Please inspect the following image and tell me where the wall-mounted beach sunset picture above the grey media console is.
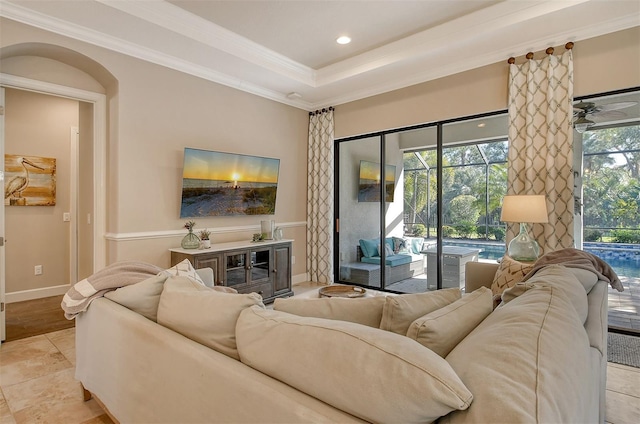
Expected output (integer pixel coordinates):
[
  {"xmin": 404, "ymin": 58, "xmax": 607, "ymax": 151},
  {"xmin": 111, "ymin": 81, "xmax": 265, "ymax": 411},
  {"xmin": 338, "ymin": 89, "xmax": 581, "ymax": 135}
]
[{"xmin": 180, "ymin": 148, "xmax": 280, "ymax": 218}]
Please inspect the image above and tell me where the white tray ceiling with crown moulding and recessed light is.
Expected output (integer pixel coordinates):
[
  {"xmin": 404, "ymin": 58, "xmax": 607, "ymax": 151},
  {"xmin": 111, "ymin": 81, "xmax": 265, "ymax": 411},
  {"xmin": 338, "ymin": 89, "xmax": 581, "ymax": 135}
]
[{"xmin": 0, "ymin": 0, "xmax": 640, "ymax": 110}]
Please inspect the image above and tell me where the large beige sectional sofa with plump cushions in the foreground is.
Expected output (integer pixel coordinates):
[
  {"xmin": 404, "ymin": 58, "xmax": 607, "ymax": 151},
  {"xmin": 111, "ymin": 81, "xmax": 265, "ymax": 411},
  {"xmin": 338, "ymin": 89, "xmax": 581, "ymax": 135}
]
[{"xmin": 76, "ymin": 263, "xmax": 607, "ymax": 423}]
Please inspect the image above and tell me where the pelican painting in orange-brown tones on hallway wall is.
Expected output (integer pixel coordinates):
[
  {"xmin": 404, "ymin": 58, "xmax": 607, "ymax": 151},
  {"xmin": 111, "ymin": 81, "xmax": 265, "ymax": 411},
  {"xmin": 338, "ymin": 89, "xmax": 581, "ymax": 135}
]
[{"xmin": 4, "ymin": 155, "xmax": 56, "ymax": 206}]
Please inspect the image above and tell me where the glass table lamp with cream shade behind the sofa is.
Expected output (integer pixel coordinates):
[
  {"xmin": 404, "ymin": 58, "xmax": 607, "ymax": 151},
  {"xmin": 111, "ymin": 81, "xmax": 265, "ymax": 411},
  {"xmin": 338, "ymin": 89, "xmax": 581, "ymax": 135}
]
[{"xmin": 500, "ymin": 194, "xmax": 549, "ymax": 262}]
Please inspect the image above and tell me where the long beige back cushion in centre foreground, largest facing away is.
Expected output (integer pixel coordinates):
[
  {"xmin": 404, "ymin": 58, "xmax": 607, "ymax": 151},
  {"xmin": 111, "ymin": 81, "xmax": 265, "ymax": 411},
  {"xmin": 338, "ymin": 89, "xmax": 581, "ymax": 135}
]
[{"xmin": 236, "ymin": 307, "xmax": 472, "ymax": 423}]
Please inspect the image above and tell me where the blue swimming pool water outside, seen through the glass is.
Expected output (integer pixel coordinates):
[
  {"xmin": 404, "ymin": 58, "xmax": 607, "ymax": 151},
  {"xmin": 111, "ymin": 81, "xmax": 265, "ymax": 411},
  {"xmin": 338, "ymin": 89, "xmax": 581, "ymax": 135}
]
[{"xmin": 444, "ymin": 239, "xmax": 640, "ymax": 278}]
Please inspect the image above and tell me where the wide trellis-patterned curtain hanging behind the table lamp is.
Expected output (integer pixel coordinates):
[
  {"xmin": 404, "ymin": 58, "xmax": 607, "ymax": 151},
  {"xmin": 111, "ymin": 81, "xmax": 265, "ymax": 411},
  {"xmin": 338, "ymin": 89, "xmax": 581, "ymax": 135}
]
[{"xmin": 507, "ymin": 48, "xmax": 574, "ymax": 255}]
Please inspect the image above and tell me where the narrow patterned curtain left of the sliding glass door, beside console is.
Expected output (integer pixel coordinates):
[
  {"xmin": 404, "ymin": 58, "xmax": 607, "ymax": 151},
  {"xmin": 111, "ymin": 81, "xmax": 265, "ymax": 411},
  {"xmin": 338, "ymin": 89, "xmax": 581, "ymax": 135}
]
[{"xmin": 307, "ymin": 108, "xmax": 334, "ymax": 283}]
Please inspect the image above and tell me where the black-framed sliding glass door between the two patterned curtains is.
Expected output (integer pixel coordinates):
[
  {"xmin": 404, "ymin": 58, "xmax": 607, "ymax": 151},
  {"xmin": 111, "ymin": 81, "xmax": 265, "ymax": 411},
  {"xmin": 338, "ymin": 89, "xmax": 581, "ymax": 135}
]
[{"xmin": 336, "ymin": 113, "xmax": 507, "ymax": 293}]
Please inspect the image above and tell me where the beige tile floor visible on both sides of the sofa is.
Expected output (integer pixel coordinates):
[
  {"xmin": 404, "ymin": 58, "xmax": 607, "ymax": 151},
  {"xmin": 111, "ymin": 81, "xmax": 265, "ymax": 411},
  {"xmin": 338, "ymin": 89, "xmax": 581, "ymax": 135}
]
[{"xmin": 0, "ymin": 328, "xmax": 640, "ymax": 424}]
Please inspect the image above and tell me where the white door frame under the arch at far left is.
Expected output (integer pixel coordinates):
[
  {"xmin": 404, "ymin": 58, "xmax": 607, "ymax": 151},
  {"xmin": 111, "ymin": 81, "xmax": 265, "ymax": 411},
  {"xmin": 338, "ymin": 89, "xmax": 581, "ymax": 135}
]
[{"xmin": 0, "ymin": 73, "xmax": 107, "ymax": 340}]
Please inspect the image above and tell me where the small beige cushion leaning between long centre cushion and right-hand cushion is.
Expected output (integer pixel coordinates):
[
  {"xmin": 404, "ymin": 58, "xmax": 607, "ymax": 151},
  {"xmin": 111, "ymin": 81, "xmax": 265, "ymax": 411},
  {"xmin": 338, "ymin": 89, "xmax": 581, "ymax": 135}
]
[{"xmin": 407, "ymin": 287, "xmax": 493, "ymax": 358}]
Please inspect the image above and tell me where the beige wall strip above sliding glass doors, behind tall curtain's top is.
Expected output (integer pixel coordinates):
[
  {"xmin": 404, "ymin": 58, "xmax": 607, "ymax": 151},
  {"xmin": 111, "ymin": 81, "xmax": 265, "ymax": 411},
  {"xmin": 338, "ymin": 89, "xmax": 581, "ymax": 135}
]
[{"xmin": 334, "ymin": 27, "xmax": 640, "ymax": 138}]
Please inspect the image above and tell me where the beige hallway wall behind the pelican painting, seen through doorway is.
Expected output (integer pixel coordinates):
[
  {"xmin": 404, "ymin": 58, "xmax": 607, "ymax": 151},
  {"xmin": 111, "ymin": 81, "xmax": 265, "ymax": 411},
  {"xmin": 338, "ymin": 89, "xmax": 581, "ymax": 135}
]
[{"xmin": 5, "ymin": 89, "xmax": 78, "ymax": 293}]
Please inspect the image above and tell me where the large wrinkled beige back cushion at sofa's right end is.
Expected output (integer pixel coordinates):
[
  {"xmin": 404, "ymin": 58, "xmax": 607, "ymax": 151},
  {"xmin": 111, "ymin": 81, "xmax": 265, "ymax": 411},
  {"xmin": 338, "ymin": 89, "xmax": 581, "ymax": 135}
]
[{"xmin": 439, "ymin": 287, "xmax": 600, "ymax": 423}]
